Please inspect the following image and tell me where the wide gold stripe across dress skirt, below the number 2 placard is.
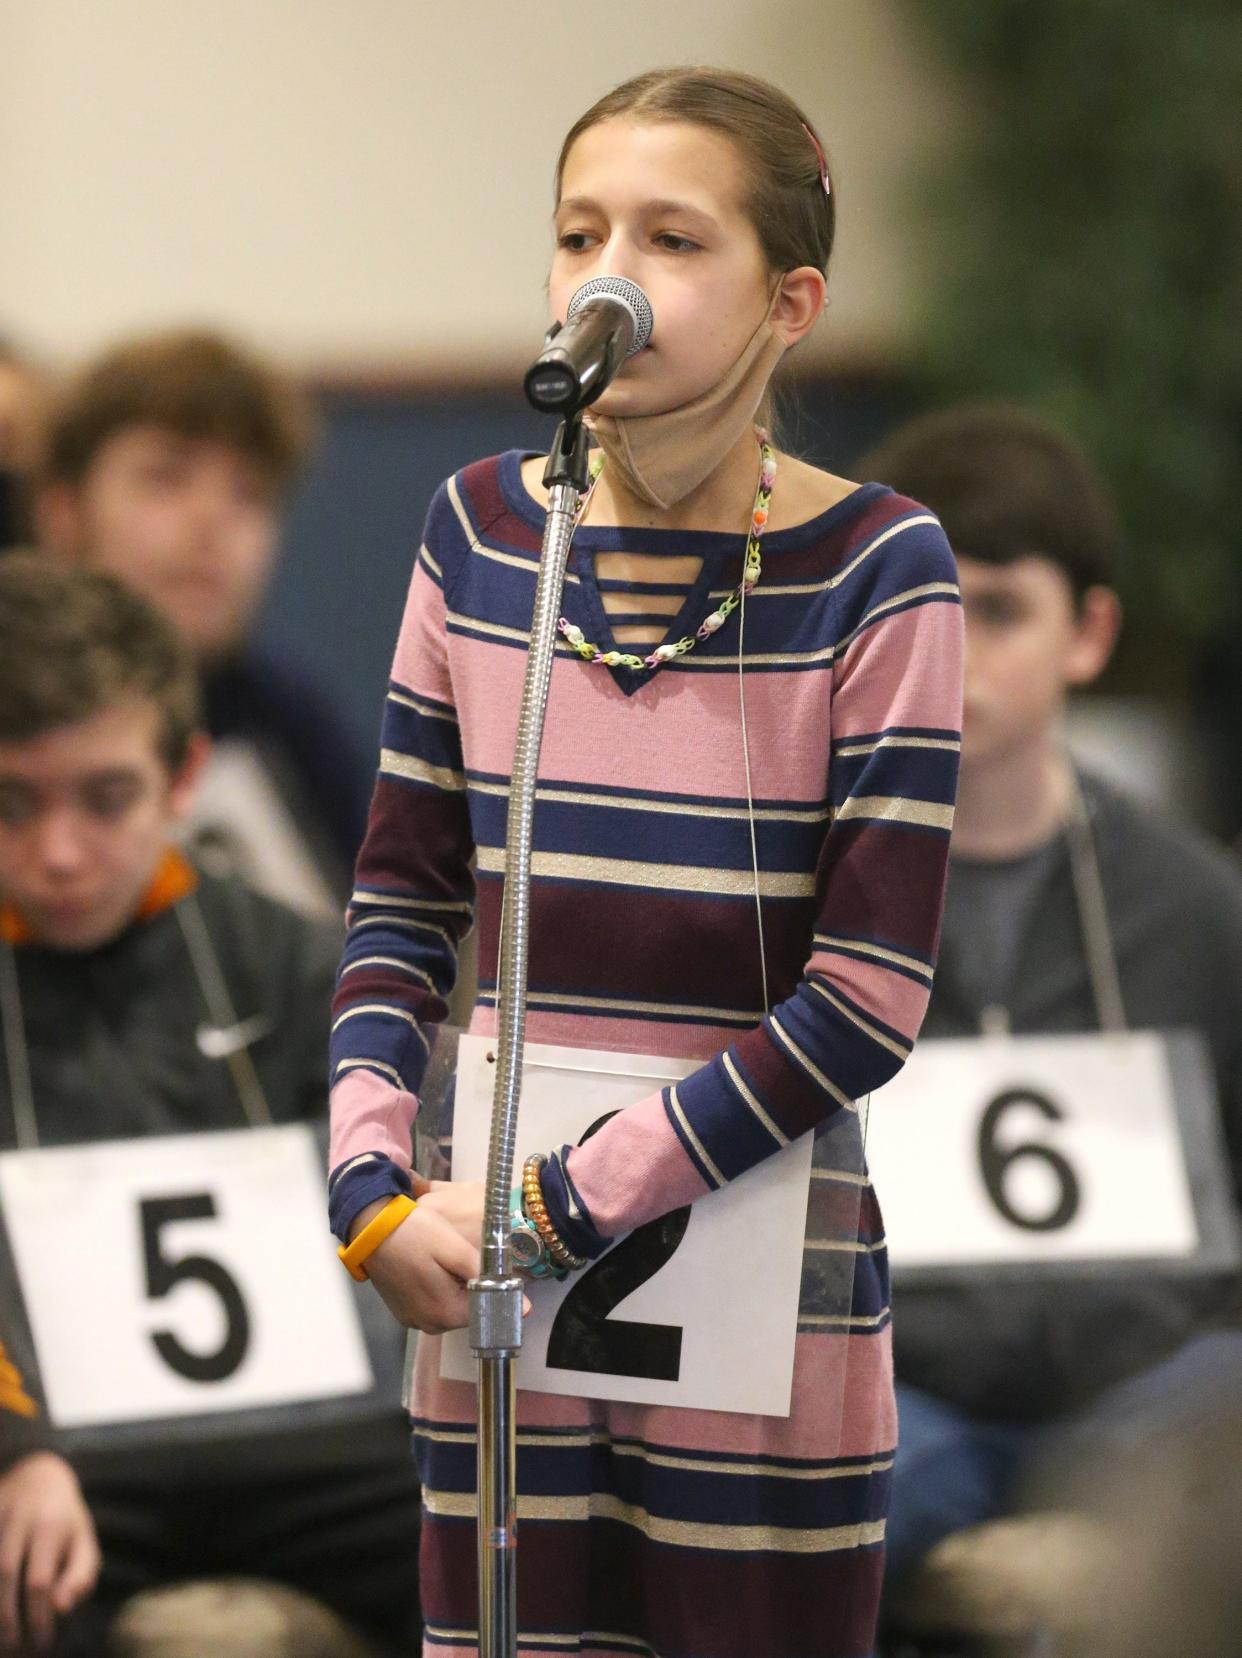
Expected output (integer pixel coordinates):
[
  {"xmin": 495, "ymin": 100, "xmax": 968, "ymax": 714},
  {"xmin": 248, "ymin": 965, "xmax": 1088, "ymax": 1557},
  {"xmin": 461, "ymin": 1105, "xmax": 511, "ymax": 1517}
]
[{"xmin": 423, "ymin": 1489, "xmax": 884, "ymax": 1555}]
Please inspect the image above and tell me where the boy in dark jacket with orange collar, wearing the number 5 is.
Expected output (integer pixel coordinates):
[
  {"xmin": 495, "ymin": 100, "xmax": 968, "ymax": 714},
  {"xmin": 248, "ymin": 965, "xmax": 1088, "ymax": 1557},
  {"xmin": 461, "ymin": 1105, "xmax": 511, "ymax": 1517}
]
[{"xmin": 0, "ymin": 554, "xmax": 418, "ymax": 1651}]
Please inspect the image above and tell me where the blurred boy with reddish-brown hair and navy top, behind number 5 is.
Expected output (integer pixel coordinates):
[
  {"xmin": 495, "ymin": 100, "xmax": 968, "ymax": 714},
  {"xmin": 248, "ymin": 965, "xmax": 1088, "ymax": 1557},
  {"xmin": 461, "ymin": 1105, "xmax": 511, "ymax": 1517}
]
[{"xmin": 35, "ymin": 330, "xmax": 370, "ymax": 915}]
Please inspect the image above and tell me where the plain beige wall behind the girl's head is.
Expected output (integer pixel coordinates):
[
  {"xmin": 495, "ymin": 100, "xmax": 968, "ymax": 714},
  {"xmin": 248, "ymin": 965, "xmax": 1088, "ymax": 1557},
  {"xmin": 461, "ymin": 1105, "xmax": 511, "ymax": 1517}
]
[{"xmin": 0, "ymin": 0, "xmax": 952, "ymax": 373}]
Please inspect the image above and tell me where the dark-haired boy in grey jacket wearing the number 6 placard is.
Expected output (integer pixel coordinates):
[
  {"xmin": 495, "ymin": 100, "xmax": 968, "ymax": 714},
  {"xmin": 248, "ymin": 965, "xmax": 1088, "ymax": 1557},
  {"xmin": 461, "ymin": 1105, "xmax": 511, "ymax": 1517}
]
[{"xmin": 866, "ymin": 405, "xmax": 1242, "ymax": 1580}]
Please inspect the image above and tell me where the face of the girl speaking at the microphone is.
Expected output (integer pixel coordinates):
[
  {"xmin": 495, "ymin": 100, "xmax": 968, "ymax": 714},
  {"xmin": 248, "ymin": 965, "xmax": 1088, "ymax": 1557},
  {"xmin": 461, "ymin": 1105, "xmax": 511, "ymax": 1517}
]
[{"xmin": 549, "ymin": 116, "xmax": 778, "ymax": 416}]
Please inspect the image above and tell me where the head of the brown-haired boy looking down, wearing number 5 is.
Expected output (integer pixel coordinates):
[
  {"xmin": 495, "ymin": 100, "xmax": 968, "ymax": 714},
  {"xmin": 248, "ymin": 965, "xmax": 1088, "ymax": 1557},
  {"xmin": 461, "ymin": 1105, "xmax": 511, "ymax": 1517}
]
[{"xmin": 0, "ymin": 554, "xmax": 207, "ymax": 950}]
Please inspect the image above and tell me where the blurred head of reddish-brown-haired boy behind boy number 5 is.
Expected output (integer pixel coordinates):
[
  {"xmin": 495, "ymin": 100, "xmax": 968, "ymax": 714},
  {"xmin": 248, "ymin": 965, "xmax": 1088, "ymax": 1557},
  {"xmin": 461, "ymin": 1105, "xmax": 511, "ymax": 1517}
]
[{"xmin": 35, "ymin": 330, "xmax": 307, "ymax": 663}]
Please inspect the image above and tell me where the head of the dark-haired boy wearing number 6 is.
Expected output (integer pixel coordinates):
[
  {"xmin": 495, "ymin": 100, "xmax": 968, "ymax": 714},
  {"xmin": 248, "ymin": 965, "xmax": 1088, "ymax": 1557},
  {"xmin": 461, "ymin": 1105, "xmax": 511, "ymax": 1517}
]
[{"xmin": 866, "ymin": 403, "xmax": 1121, "ymax": 781}]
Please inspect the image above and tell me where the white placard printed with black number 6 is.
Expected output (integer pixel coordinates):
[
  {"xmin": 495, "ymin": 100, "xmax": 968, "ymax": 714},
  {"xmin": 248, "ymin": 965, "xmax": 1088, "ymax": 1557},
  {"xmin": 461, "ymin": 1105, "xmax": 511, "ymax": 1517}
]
[{"xmin": 867, "ymin": 1031, "xmax": 1199, "ymax": 1267}]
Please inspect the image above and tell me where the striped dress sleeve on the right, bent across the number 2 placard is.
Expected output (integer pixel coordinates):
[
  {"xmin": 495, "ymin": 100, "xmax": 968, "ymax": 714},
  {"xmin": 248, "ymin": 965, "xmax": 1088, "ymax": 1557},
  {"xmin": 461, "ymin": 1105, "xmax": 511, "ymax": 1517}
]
[{"xmin": 544, "ymin": 514, "xmax": 962, "ymax": 1255}]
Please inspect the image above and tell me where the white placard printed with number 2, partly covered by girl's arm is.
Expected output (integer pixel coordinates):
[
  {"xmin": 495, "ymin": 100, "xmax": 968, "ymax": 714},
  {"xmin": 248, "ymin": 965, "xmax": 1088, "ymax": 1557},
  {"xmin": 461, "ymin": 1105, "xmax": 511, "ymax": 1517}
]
[{"xmin": 441, "ymin": 1036, "xmax": 813, "ymax": 1416}]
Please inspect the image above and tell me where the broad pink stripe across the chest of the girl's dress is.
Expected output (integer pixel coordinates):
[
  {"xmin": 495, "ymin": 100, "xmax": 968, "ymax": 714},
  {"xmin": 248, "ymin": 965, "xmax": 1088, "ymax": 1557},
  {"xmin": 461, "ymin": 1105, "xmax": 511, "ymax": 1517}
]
[{"xmin": 449, "ymin": 635, "xmax": 829, "ymax": 802}]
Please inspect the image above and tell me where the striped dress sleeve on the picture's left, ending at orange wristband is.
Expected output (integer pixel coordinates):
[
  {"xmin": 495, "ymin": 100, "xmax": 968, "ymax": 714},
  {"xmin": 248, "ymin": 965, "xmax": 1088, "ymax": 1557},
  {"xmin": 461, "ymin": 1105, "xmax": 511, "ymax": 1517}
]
[{"xmin": 330, "ymin": 489, "xmax": 474, "ymax": 1237}]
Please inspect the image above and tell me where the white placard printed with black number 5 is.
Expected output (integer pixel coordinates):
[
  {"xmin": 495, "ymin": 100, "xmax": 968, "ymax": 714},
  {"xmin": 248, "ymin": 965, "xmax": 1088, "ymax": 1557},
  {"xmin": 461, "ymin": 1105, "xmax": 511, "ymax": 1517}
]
[{"xmin": 0, "ymin": 1124, "xmax": 373, "ymax": 1428}]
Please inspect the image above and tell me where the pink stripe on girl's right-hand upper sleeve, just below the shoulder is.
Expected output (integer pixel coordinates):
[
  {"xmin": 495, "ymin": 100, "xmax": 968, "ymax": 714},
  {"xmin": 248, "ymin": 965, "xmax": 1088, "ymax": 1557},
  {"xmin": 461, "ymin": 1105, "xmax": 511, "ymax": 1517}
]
[{"xmin": 834, "ymin": 604, "xmax": 962, "ymax": 741}]
